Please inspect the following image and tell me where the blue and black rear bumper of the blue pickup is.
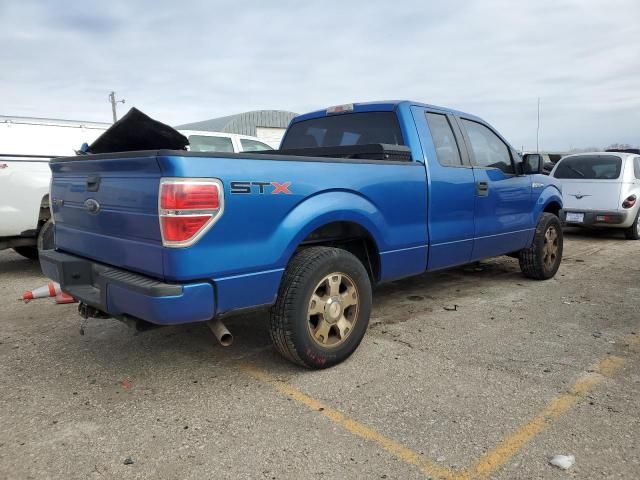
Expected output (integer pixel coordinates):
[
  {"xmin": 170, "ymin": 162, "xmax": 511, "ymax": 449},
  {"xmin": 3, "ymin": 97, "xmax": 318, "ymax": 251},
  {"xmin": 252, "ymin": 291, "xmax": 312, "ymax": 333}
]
[{"xmin": 40, "ymin": 250, "xmax": 215, "ymax": 325}]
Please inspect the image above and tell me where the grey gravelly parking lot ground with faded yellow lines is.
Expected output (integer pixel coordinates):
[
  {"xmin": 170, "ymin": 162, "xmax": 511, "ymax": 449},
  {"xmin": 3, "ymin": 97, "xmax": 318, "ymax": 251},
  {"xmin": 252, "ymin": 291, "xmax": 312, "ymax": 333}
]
[{"xmin": 0, "ymin": 231, "xmax": 640, "ymax": 479}]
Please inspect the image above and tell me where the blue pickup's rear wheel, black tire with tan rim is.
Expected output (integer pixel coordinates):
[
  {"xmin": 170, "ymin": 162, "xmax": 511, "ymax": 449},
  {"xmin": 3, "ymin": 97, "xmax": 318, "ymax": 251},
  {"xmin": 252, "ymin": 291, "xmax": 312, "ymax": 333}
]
[{"xmin": 269, "ymin": 247, "xmax": 371, "ymax": 369}]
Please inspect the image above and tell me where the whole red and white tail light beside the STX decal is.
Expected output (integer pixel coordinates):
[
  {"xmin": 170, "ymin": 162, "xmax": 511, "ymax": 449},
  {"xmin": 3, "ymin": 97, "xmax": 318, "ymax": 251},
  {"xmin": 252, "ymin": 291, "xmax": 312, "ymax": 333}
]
[{"xmin": 158, "ymin": 178, "xmax": 224, "ymax": 248}]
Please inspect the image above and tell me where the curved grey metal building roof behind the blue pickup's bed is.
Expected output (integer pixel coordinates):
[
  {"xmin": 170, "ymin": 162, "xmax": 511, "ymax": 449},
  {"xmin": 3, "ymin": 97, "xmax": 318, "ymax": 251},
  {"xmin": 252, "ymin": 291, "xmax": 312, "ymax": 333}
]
[{"xmin": 175, "ymin": 110, "xmax": 297, "ymax": 137}]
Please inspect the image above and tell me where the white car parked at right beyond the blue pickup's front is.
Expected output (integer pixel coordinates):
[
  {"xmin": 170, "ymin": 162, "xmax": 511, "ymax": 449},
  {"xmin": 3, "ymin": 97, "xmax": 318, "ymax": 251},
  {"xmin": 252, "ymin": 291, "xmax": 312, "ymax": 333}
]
[{"xmin": 551, "ymin": 152, "xmax": 640, "ymax": 240}]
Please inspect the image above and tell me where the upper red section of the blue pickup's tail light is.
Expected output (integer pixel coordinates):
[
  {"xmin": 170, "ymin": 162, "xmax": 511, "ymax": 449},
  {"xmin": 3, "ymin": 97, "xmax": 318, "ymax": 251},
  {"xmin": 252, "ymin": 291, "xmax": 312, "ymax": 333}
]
[{"xmin": 160, "ymin": 182, "xmax": 220, "ymax": 210}]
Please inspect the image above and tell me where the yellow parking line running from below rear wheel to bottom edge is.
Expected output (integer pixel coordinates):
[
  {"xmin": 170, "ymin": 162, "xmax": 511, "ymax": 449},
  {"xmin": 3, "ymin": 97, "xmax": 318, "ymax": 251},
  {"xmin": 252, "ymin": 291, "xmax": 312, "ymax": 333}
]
[{"xmin": 240, "ymin": 364, "xmax": 459, "ymax": 480}]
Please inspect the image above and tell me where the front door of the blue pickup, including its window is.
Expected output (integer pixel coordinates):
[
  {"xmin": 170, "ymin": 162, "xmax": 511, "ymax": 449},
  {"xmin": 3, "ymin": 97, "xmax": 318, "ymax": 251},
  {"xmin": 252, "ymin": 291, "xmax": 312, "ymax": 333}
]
[{"xmin": 459, "ymin": 117, "xmax": 535, "ymax": 260}]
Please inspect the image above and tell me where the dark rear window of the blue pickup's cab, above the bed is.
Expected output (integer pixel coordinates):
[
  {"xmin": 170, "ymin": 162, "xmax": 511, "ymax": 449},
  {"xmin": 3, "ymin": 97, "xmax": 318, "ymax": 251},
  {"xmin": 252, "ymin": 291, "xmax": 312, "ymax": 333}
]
[{"xmin": 280, "ymin": 112, "xmax": 405, "ymax": 150}]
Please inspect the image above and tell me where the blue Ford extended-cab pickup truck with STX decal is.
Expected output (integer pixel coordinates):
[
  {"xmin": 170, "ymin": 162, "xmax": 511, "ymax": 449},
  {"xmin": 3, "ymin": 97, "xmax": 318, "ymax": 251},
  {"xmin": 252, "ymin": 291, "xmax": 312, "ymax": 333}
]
[{"xmin": 40, "ymin": 101, "xmax": 562, "ymax": 368}]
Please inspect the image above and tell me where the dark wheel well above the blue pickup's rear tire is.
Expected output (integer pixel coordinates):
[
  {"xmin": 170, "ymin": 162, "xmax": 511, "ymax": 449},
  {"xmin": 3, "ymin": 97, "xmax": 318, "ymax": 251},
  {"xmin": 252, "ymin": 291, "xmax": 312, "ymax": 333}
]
[{"xmin": 298, "ymin": 222, "xmax": 380, "ymax": 282}]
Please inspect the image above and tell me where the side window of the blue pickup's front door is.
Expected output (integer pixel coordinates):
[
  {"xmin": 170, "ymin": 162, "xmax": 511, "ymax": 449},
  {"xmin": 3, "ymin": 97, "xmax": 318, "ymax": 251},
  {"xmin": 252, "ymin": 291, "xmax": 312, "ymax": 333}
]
[{"xmin": 462, "ymin": 118, "xmax": 515, "ymax": 173}]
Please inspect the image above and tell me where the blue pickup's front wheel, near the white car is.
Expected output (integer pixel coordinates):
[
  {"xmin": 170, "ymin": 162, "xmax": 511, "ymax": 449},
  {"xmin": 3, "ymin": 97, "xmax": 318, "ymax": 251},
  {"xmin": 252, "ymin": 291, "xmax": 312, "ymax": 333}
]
[{"xmin": 520, "ymin": 213, "xmax": 563, "ymax": 280}]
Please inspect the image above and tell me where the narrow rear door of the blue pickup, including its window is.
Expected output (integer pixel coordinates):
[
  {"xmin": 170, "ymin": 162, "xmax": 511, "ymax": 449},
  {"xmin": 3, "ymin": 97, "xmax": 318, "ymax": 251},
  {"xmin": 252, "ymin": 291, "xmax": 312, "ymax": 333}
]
[{"xmin": 412, "ymin": 107, "xmax": 475, "ymax": 270}]
